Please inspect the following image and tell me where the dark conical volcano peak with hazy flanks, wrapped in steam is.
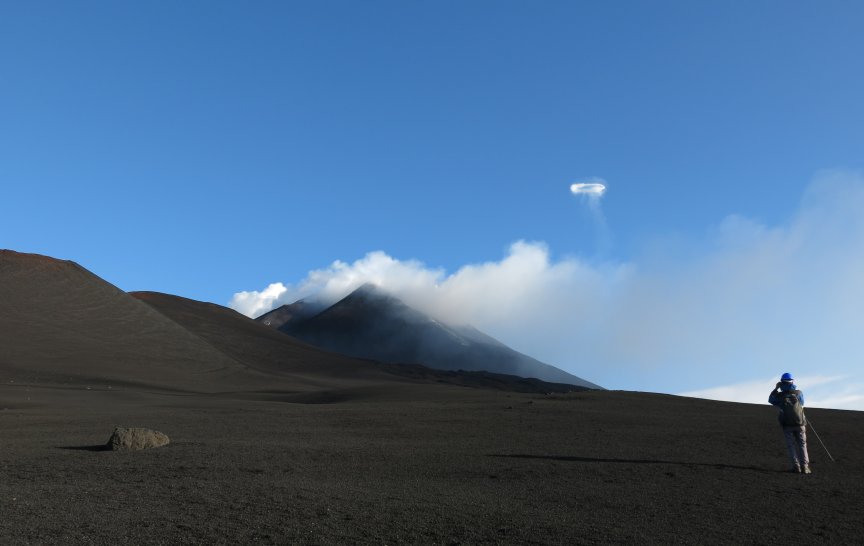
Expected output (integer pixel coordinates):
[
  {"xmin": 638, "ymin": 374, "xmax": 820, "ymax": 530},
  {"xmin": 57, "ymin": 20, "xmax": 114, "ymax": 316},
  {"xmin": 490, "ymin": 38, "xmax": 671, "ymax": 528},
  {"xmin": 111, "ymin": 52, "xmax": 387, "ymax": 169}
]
[{"xmin": 256, "ymin": 284, "xmax": 602, "ymax": 389}]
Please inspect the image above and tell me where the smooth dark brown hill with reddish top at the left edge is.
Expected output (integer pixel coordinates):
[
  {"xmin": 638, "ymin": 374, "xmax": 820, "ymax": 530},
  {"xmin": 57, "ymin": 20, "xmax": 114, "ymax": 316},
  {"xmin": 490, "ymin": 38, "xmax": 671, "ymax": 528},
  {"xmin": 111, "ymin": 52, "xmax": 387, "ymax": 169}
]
[{"xmin": 0, "ymin": 250, "xmax": 263, "ymax": 392}]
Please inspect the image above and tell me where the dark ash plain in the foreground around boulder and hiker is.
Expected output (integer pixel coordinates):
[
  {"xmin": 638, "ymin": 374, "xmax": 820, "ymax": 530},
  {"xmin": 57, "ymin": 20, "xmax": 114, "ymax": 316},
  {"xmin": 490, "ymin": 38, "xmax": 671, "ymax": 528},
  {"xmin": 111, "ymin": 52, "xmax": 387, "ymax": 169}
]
[{"xmin": 0, "ymin": 384, "xmax": 864, "ymax": 545}]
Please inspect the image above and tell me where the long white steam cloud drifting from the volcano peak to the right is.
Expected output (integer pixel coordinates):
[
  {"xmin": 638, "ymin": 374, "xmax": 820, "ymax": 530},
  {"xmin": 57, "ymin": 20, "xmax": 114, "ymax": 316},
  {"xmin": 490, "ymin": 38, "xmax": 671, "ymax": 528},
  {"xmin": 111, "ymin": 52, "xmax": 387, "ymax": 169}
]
[{"xmin": 230, "ymin": 172, "xmax": 864, "ymax": 409}]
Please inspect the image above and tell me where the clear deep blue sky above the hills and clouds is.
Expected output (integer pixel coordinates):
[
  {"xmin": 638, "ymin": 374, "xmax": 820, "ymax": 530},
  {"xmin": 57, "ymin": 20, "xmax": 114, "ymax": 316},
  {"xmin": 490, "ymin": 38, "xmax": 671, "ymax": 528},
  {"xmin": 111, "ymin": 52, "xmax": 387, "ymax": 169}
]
[{"xmin": 0, "ymin": 1, "xmax": 864, "ymax": 404}]
